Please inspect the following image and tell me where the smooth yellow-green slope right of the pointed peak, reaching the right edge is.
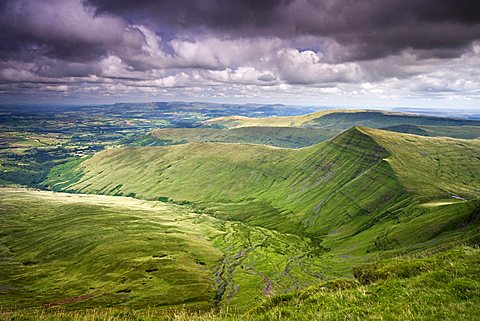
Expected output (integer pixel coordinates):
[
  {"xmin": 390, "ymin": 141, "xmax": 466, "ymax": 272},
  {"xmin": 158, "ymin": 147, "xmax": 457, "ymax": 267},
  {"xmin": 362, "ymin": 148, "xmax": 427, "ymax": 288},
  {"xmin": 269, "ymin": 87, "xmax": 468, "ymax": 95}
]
[{"xmin": 362, "ymin": 128, "xmax": 480, "ymax": 199}]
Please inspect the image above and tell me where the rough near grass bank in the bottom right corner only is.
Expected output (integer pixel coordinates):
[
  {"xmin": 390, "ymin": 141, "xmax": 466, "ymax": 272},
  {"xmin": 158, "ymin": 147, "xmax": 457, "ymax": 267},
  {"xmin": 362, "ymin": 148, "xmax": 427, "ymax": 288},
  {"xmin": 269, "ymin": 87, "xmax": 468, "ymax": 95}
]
[{"xmin": 252, "ymin": 247, "xmax": 480, "ymax": 320}]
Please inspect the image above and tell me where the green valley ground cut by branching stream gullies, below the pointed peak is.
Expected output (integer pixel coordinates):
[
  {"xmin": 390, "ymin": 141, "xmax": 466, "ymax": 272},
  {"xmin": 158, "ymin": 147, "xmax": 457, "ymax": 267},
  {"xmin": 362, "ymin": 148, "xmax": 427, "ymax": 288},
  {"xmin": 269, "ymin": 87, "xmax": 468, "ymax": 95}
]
[{"xmin": 213, "ymin": 221, "xmax": 323, "ymax": 306}]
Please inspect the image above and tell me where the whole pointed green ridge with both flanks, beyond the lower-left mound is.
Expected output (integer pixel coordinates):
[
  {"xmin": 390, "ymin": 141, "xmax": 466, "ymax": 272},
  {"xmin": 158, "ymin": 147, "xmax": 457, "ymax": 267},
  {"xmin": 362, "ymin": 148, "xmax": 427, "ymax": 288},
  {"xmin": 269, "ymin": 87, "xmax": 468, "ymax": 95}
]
[{"xmin": 45, "ymin": 128, "xmax": 480, "ymax": 254}]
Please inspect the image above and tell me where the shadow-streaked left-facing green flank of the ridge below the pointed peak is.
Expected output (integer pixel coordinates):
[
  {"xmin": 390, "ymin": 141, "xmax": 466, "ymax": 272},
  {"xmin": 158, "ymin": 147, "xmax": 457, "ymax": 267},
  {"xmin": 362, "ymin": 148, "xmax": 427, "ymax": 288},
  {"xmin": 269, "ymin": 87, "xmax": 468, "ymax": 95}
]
[{"xmin": 45, "ymin": 130, "xmax": 402, "ymax": 234}]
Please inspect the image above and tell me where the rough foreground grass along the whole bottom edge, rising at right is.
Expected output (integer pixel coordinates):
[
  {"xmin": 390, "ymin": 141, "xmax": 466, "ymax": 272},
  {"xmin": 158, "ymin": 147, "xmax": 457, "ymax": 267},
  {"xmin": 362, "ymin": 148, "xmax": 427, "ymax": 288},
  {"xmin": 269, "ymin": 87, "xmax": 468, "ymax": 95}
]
[{"xmin": 0, "ymin": 246, "xmax": 480, "ymax": 321}]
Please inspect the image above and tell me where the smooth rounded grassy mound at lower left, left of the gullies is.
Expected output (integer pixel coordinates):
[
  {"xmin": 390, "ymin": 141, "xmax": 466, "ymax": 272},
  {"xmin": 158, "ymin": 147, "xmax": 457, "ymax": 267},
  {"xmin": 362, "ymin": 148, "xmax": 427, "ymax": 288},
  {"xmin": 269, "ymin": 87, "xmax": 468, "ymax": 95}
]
[{"xmin": 0, "ymin": 189, "xmax": 222, "ymax": 307}]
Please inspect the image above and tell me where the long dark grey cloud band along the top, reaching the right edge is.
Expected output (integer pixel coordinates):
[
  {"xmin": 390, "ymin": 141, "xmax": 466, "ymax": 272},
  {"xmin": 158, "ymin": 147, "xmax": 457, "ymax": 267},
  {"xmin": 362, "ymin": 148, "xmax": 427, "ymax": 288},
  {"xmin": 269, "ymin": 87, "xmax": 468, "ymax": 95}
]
[{"xmin": 87, "ymin": 0, "xmax": 480, "ymax": 60}]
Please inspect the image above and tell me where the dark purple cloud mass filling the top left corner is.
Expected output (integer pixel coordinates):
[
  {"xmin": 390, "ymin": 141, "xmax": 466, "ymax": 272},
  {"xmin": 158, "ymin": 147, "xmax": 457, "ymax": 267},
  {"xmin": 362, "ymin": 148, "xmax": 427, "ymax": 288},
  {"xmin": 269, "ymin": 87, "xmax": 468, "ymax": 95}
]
[{"xmin": 0, "ymin": 0, "xmax": 144, "ymax": 61}]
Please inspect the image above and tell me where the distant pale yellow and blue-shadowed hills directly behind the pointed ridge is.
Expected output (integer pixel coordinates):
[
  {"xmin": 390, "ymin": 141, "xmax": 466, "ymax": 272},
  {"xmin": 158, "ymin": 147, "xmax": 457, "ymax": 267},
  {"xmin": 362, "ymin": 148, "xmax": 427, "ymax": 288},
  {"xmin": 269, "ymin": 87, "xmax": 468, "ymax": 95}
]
[{"xmin": 142, "ymin": 110, "xmax": 480, "ymax": 148}]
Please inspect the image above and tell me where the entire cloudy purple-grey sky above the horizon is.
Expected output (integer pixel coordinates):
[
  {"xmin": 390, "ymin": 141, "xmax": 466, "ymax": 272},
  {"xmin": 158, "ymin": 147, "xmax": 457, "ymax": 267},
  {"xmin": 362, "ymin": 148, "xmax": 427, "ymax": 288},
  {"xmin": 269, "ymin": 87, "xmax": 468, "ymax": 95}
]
[{"xmin": 0, "ymin": 0, "xmax": 480, "ymax": 109}]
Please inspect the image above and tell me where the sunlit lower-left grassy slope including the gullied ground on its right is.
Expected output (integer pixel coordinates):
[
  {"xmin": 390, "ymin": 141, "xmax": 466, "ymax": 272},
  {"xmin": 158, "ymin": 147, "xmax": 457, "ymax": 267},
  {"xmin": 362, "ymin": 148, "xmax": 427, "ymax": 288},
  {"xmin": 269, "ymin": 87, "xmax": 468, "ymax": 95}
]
[{"xmin": 0, "ymin": 188, "xmax": 332, "ymax": 309}]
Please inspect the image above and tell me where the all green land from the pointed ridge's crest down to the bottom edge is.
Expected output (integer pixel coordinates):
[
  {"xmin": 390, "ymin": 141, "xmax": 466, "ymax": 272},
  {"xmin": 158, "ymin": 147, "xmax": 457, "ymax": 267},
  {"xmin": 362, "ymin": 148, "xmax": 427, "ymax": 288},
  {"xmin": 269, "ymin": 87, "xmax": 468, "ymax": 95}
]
[{"xmin": 4, "ymin": 127, "xmax": 480, "ymax": 320}]
